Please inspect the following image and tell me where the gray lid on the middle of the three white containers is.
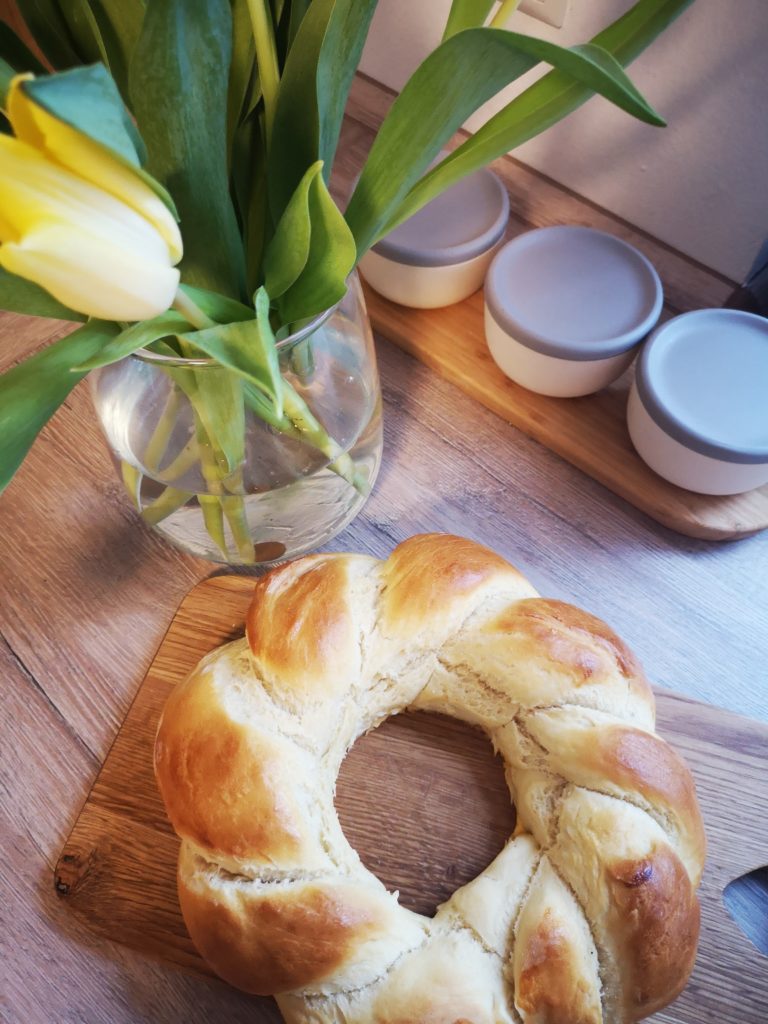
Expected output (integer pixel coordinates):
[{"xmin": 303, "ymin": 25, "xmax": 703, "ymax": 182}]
[{"xmin": 485, "ymin": 224, "xmax": 664, "ymax": 360}]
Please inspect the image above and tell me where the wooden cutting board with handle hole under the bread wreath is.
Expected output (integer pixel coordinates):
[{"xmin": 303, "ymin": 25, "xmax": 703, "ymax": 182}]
[{"xmin": 55, "ymin": 575, "xmax": 768, "ymax": 1024}]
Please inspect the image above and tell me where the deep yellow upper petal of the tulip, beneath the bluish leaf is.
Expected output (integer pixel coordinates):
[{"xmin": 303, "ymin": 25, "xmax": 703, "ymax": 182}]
[{"xmin": 8, "ymin": 75, "xmax": 183, "ymax": 263}]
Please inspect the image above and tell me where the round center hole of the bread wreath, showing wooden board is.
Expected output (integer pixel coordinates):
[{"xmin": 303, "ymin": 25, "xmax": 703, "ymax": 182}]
[{"xmin": 336, "ymin": 712, "xmax": 515, "ymax": 918}]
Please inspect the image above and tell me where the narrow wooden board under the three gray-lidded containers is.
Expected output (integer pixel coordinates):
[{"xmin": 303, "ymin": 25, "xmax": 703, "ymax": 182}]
[{"xmin": 366, "ymin": 286, "xmax": 768, "ymax": 541}]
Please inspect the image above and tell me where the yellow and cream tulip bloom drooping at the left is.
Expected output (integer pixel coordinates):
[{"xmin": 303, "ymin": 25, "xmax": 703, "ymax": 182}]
[{"xmin": 0, "ymin": 76, "xmax": 182, "ymax": 321}]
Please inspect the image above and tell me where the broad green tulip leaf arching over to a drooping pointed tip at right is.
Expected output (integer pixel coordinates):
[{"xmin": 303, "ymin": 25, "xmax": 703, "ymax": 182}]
[{"xmin": 346, "ymin": 29, "xmax": 664, "ymax": 256}]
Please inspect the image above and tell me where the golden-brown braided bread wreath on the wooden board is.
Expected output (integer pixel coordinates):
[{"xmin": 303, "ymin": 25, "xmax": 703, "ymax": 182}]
[{"xmin": 156, "ymin": 535, "xmax": 705, "ymax": 1024}]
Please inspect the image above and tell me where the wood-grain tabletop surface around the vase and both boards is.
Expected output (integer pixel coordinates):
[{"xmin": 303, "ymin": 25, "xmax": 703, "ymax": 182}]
[{"xmin": 0, "ymin": 64, "xmax": 768, "ymax": 1024}]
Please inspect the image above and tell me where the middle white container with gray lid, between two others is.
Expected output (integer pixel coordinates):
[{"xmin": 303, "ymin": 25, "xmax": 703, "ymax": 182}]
[{"xmin": 485, "ymin": 225, "xmax": 664, "ymax": 398}]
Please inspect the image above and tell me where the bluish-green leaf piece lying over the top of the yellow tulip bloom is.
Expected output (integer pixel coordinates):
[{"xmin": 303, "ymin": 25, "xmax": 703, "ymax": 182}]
[{"xmin": 22, "ymin": 65, "xmax": 178, "ymax": 220}]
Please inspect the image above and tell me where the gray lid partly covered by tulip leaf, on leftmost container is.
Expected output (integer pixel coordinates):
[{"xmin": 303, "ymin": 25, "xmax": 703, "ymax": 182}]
[{"xmin": 373, "ymin": 168, "xmax": 509, "ymax": 266}]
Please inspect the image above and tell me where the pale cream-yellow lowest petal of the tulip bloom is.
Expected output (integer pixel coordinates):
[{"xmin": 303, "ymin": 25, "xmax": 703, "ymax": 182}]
[{"xmin": 0, "ymin": 224, "xmax": 179, "ymax": 321}]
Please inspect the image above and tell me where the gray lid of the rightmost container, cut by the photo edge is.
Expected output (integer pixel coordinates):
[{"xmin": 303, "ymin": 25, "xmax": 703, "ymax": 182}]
[{"xmin": 637, "ymin": 309, "xmax": 768, "ymax": 463}]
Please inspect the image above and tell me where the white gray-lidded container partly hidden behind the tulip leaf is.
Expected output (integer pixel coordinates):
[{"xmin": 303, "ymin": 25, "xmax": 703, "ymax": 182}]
[{"xmin": 359, "ymin": 163, "xmax": 509, "ymax": 309}]
